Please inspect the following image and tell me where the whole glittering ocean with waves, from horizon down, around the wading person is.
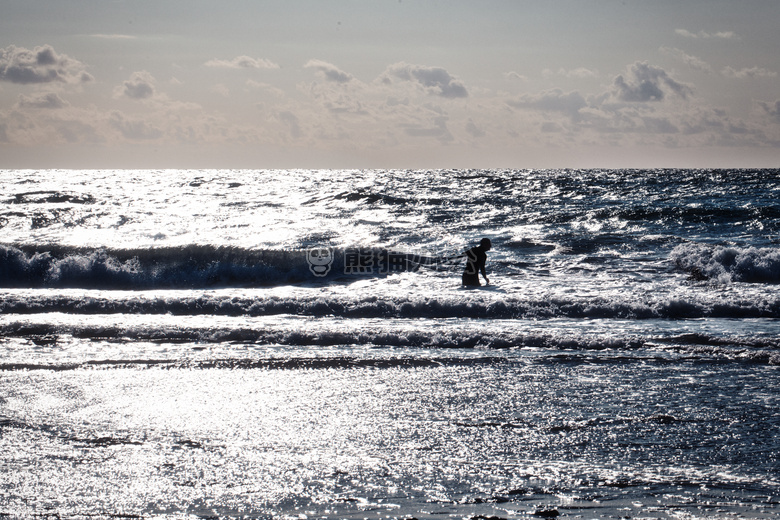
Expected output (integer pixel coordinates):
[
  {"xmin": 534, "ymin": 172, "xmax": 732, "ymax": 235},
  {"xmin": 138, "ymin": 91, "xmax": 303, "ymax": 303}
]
[{"xmin": 0, "ymin": 169, "xmax": 780, "ymax": 519}]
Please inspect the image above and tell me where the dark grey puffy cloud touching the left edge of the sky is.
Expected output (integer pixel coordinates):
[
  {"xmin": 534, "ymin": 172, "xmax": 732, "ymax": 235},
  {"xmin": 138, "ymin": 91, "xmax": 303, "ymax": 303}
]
[{"xmin": 0, "ymin": 45, "xmax": 94, "ymax": 85}]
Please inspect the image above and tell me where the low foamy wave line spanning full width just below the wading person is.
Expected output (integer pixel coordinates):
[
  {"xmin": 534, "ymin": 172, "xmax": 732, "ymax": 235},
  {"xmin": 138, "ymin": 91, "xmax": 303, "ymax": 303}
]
[{"xmin": 0, "ymin": 291, "xmax": 780, "ymax": 320}]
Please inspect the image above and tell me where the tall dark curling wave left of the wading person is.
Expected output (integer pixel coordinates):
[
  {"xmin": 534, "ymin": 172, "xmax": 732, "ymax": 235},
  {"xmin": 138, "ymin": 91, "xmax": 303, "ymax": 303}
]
[{"xmin": 0, "ymin": 245, "xmax": 454, "ymax": 289}]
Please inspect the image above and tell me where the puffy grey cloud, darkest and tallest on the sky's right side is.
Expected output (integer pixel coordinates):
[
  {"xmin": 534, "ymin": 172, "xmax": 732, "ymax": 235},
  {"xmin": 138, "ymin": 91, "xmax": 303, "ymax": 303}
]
[{"xmin": 613, "ymin": 62, "xmax": 693, "ymax": 103}]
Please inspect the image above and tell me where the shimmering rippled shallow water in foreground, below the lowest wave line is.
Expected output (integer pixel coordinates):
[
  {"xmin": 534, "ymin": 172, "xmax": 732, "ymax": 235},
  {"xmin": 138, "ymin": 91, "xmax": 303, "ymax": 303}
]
[{"xmin": 0, "ymin": 350, "xmax": 780, "ymax": 516}]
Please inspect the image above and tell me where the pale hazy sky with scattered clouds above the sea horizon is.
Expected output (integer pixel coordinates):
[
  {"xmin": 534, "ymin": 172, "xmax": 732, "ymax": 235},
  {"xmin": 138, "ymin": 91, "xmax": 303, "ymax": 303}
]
[{"xmin": 0, "ymin": 0, "xmax": 780, "ymax": 168}]
